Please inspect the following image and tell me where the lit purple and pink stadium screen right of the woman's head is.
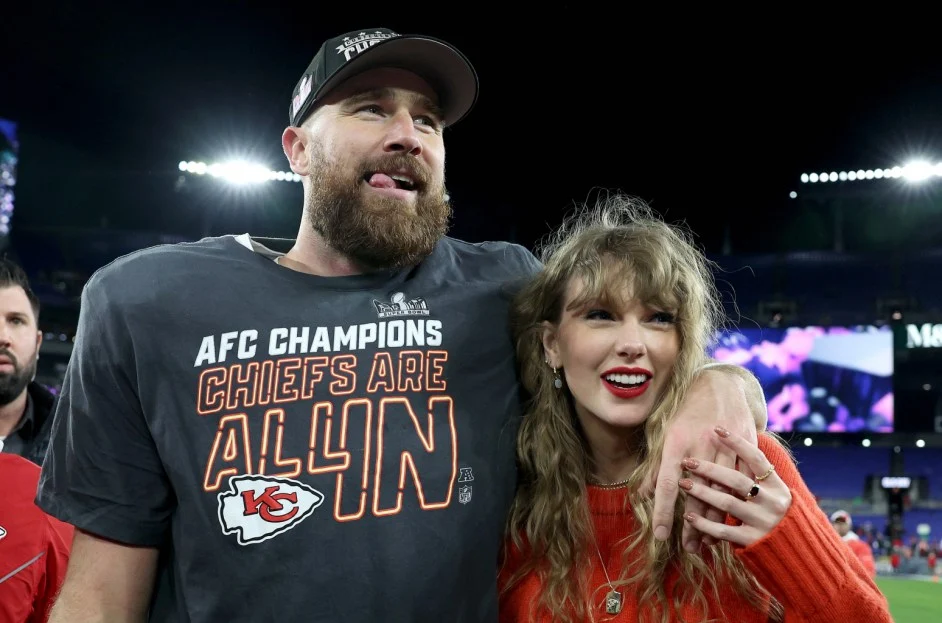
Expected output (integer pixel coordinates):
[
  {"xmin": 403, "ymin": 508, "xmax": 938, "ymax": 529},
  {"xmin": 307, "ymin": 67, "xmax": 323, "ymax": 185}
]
[{"xmin": 709, "ymin": 326, "xmax": 894, "ymax": 433}]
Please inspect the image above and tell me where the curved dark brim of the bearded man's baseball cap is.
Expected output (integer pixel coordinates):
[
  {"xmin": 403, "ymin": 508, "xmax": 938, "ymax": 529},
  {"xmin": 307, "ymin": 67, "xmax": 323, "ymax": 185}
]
[{"xmin": 310, "ymin": 35, "xmax": 478, "ymax": 125}]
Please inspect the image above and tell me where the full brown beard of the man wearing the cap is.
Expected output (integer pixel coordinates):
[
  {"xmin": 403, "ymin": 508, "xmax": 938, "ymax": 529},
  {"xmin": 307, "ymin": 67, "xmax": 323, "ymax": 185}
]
[{"xmin": 307, "ymin": 147, "xmax": 451, "ymax": 271}]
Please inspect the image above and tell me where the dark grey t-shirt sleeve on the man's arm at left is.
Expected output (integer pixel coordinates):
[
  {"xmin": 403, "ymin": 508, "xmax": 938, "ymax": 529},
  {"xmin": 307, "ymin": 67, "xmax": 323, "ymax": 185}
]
[{"xmin": 36, "ymin": 268, "xmax": 175, "ymax": 547}]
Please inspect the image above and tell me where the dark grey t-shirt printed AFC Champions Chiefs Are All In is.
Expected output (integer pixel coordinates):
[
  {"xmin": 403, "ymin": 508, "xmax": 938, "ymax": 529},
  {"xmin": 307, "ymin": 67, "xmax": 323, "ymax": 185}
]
[{"xmin": 37, "ymin": 236, "xmax": 539, "ymax": 623}]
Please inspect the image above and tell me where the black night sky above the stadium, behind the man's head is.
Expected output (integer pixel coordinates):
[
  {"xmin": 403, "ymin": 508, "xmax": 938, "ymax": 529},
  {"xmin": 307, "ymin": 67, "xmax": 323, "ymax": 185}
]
[{"xmin": 0, "ymin": 0, "xmax": 942, "ymax": 251}]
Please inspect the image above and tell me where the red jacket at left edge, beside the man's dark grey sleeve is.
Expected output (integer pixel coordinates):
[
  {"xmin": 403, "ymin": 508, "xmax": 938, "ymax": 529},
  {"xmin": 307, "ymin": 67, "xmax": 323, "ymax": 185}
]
[{"xmin": 0, "ymin": 453, "xmax": 73, "ymax": 623}]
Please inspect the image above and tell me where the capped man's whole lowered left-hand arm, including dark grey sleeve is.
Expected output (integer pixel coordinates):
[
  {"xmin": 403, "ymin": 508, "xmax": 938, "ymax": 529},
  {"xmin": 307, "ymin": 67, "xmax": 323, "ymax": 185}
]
[{"xmin": 36, "ymin": 272, "xmax": 170, "ymax": 623}]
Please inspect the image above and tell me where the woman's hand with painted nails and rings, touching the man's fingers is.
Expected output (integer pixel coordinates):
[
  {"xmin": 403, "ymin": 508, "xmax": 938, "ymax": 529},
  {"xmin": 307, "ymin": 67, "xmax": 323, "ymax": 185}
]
[{"xmin": 678, "ymin": 426, "xmax": 792, "ymax": 546}]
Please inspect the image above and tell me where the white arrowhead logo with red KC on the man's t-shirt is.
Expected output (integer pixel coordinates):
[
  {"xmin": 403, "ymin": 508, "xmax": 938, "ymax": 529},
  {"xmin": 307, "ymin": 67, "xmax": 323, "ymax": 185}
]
[{"xmin": 219, "ymin": 474, "xmax": 324, "ymax": 545}]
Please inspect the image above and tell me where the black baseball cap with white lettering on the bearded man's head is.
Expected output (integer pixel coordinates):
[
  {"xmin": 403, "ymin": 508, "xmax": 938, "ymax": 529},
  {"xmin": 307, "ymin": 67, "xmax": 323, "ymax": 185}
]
[{"xmin": 288, "ymin": 28, "xmax": 478, "ymax": 126}]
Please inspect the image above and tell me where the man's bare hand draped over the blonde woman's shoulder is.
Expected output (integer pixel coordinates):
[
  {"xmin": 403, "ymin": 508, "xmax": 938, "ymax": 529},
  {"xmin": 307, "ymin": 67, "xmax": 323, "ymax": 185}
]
[{"xmin": 643, "ymin": 365, "xmax": 767, "ymax": 551}]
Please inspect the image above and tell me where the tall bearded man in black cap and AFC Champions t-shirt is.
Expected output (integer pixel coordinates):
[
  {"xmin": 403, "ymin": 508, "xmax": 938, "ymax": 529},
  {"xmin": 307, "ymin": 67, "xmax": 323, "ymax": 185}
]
[{"xmin": 37, "ymin": 28, "xmax": 776, "ymax": 623}]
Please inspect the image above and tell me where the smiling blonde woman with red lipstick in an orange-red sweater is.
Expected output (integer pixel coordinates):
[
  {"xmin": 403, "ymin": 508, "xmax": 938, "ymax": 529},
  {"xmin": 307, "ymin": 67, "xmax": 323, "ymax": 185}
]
[{"xmin": 500, "ymin": 195, "xmax": 892, "ymax": 623}]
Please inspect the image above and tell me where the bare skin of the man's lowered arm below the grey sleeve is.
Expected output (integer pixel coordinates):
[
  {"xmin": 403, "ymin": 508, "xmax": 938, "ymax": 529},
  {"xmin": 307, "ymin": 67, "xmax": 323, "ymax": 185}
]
[{"xmin": 49, "ymin": 530, "xmax": 158, "ymax": 623}]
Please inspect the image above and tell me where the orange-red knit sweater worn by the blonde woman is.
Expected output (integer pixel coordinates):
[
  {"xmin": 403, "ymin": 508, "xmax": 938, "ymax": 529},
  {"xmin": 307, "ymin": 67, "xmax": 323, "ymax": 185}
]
[{"xmin": 500, "ymin": 435, "xmax": 893, "ymax": 623}]
